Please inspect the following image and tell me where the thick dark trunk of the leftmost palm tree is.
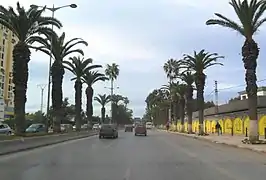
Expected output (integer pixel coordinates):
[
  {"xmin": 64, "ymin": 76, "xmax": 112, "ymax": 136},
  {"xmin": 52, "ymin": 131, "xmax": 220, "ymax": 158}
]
[{"xmin": 13, "ymin": 42, "xmax": 31, "ymax": 136}]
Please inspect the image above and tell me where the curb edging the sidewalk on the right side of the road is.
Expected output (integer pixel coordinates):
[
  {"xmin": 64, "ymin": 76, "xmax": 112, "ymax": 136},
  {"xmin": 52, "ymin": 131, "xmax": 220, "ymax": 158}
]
[{"xmin": 158, "ymin": 130, "xmax": 266, "ymax": 153}]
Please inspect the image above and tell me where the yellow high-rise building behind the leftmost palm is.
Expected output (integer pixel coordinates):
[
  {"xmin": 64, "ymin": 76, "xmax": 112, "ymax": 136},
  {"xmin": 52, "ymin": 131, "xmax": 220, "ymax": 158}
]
[{"xmin": 0, "ymin": 25, "xmax": 17, "ymax": 118}]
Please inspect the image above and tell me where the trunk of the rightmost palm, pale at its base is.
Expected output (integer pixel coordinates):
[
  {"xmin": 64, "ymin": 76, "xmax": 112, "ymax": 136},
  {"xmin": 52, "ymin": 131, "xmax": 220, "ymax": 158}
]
[{"xmin": 242, "ymin": 39, "xmax": 259, "ymax": 142}]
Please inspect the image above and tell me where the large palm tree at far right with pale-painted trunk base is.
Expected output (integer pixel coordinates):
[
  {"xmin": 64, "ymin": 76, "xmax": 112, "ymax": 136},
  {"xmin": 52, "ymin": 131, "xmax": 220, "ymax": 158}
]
[{"xmin": 206, "ymin": 0, "xmax": 266, "ymax": 142}]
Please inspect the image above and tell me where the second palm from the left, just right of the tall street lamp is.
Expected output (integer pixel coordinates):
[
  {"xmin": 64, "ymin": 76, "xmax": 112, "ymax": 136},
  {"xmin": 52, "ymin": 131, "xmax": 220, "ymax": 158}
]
[{"xmin": 38, "ymin": 33, "xmax": 88, "ymax": 132}]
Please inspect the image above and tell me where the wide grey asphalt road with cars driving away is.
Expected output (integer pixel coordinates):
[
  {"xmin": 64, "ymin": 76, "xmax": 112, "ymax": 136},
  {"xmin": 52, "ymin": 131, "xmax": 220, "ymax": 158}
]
[{"xmin": 0, "ymin": 131, "xmax": 266, "ymax": 180}]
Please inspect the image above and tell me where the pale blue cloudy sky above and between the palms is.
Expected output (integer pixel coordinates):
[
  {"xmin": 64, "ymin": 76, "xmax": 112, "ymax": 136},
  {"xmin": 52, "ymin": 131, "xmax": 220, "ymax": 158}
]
[{"xmin": 1, "ymin": 0, "xmax": 266, "ymax": 117}]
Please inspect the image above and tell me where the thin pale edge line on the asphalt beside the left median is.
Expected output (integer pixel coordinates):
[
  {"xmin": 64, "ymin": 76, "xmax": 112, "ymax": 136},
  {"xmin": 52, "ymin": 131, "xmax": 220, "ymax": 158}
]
[{"xmin": 0, "ymin": 135, "xmax": 96, "ymax": 162}]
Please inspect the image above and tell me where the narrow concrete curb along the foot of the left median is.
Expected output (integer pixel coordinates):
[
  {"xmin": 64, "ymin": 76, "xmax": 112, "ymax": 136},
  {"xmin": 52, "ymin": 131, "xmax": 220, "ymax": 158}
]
[{"xmin": 0, "ymin": 133, "xmax": 97, "ymax": 157}]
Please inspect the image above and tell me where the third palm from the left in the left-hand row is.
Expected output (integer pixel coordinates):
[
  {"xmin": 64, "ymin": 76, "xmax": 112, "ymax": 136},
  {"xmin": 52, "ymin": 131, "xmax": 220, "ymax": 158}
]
[{"xmin": 63, "ymin": 56, "xmax": 102, "ymax": 131}]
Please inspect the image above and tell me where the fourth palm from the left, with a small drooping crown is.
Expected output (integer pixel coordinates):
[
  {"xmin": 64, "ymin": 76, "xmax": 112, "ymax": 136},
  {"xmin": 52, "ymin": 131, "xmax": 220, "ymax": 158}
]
[{"xmin": 82, "ymin": 71, "xmax": 108, "ymax": 124}]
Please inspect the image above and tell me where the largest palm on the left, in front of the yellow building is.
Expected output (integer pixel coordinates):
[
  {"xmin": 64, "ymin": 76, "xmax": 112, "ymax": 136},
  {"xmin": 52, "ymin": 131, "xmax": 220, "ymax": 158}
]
[{"xmin": 0, "ymin": 3, "xmax": 62, "ymax": 135}]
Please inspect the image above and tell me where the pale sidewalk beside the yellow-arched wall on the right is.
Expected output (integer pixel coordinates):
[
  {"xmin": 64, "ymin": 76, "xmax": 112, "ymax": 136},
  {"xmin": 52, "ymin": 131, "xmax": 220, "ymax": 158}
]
[{"xmin": 160, "ymin": 130, "xmax": 266, "ymax": 153}]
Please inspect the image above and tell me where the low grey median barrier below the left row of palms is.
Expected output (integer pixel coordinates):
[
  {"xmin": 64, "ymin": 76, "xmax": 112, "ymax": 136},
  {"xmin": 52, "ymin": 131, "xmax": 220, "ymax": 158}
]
[{"xmin": 0, "ymin": 131, "xmax": 97, "ymax": 155}]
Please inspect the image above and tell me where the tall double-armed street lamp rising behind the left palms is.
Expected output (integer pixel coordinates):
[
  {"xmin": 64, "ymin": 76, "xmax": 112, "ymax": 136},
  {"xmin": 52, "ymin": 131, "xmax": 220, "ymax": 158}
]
[{"xmin": 30, "ymin": 4, "xmax": 78, "ymax": 128}]
